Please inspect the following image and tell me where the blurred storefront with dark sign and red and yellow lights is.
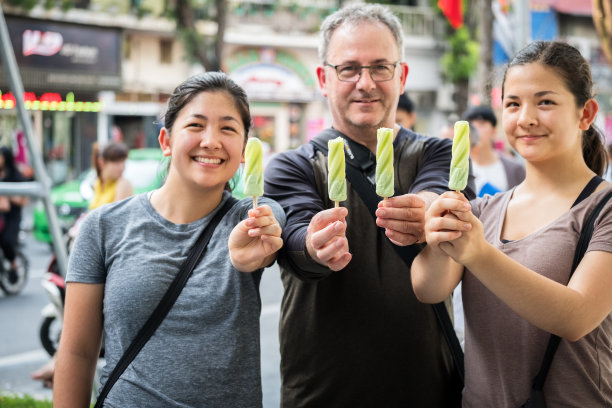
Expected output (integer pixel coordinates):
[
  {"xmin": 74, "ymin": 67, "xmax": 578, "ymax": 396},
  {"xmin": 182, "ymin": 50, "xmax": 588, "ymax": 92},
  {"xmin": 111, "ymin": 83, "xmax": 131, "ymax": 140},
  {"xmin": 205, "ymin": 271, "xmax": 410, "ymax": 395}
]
[{"xmin": 0, "ymin": 16, "xmax": 121, "ymax": 183}]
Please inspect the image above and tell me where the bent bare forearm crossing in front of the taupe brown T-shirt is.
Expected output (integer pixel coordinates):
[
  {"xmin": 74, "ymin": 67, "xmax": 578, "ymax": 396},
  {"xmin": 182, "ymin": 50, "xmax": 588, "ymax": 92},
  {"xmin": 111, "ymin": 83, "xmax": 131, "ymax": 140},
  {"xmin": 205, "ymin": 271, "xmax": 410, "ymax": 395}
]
[{"xmin": 441, "ymin": 207, "xmax": 612, "ymax": 341}]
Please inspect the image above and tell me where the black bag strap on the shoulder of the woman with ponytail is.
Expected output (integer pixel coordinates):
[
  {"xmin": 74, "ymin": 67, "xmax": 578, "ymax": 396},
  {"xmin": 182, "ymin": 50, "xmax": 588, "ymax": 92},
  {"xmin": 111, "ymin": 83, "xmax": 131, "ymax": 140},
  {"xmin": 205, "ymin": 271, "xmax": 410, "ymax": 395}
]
[{"xmin": 533, "ymin": 186, "xmax": 612, "ymax": 391}]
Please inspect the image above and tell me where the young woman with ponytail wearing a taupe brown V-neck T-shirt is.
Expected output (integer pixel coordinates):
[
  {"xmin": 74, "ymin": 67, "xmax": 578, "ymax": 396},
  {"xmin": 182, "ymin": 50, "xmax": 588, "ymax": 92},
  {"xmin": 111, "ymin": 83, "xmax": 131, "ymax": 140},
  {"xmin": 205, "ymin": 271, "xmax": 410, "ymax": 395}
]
[{"xmin": 412, "ymin": 42, "xmax": 612, "ymax": 407}]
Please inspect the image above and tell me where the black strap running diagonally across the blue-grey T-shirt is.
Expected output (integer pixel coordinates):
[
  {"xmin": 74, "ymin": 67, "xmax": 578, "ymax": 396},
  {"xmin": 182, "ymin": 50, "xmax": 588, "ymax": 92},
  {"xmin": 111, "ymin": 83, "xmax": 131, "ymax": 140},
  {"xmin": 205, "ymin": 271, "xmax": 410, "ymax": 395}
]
[{"xmin": 94, "ymin": 197, "xmax": 238, "ymax": 408}]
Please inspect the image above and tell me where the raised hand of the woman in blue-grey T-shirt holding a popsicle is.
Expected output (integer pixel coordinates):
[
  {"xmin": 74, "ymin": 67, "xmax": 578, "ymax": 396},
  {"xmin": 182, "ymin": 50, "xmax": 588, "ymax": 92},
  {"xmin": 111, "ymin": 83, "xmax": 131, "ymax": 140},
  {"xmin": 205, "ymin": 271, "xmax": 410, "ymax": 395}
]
[{"xmin": 227, "ymin": 205, "xmax": 283, "ymax": 272}]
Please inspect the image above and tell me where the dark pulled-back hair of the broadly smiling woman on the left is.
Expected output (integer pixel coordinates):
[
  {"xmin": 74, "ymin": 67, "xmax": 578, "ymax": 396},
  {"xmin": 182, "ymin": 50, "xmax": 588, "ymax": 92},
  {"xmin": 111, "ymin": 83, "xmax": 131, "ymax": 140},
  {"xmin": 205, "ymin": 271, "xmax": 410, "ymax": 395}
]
[{"xmin": 163, "ymin": 72, "xmax": 251, "ymax": 191}]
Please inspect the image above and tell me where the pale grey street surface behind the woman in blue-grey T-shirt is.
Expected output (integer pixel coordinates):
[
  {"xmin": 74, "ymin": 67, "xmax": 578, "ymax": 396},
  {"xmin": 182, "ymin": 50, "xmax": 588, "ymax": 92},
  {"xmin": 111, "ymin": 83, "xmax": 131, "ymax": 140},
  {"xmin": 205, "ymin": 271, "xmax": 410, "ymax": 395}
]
[{"xmin": 0, "ymin": 230, "xmax": 282, "ymax": 408}]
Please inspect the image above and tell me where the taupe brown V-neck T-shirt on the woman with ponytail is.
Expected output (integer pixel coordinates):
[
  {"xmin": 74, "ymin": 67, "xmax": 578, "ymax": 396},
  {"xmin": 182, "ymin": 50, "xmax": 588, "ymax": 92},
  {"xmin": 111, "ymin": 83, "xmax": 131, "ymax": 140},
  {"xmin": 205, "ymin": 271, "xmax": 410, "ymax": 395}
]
[{"xmin": 463, "ymin": 187, "xmax": 612, "ymax": 408}]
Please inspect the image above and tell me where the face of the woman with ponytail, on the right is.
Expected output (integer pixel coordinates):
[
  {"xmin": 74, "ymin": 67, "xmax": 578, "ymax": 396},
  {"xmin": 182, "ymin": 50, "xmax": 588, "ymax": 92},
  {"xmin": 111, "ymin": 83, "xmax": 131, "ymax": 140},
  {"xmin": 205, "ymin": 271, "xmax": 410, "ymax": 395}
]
[{"xmin": 502, "ymin": 62, "xmax": 597, "ymax": 162}]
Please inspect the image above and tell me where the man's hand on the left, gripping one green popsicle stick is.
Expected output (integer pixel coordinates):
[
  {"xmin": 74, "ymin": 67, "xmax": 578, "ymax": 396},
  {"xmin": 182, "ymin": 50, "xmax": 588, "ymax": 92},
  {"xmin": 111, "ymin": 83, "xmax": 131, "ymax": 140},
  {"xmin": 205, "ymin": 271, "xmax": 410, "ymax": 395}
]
[{"xmin": 306, "ymin": 207, "xmax": 353, "ymax": 271}]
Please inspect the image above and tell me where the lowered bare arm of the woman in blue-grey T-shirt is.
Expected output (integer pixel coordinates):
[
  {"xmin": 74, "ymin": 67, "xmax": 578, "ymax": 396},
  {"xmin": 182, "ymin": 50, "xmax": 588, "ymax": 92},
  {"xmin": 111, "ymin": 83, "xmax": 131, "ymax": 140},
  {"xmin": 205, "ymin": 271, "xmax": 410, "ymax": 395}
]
[{"xmin": 53, "ymin": 283, "xmax": 104, "ymax": 408}]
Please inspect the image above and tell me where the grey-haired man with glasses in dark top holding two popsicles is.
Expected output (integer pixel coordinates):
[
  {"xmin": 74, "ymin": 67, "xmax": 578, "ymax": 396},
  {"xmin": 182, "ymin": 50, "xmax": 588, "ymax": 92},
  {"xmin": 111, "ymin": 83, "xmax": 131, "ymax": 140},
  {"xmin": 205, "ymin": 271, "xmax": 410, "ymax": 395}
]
[{"xmin": 265, "ymin": 4, "xmax": 473, "ymax": 408}]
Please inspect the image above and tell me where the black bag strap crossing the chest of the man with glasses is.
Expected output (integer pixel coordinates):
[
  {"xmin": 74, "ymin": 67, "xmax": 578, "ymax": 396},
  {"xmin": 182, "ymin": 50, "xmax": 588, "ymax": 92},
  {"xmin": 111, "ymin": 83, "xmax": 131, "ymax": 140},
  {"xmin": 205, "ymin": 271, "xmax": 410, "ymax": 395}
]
[{"xmin": 310, "ymin": 129, "xmax": 464, "ymax": 385}]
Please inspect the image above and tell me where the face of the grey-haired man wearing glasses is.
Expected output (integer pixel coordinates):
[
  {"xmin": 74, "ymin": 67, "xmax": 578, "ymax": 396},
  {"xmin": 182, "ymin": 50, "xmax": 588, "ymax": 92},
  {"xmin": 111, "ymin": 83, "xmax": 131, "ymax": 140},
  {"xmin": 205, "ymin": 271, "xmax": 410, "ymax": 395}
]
[{"xmin": 317, "ymin": 22, "xmax": 408, "ymax": 145}]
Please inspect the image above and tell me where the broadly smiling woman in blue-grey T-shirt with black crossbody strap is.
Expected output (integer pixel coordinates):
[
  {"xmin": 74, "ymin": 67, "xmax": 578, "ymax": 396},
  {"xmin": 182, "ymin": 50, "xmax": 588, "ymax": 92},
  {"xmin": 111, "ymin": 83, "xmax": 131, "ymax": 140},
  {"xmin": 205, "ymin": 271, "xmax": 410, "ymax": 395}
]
[{"xmin": 53, "ymin": 72, "xmax": 285, "ymax": 408}]
